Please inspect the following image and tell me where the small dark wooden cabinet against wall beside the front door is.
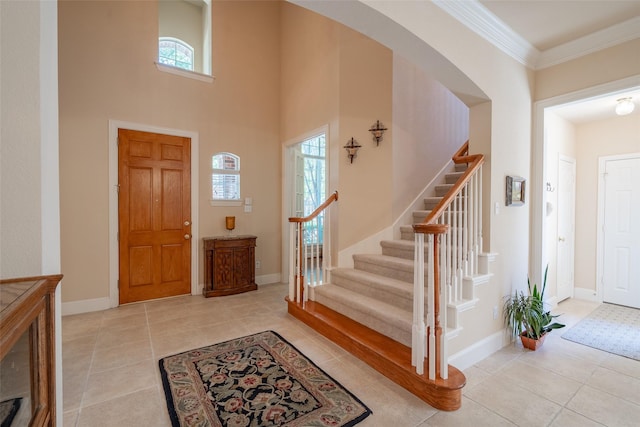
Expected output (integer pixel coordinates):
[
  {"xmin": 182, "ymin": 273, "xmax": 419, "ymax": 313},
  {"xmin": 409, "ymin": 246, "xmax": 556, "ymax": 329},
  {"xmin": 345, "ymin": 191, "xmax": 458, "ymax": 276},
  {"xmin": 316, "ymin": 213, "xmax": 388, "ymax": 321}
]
[{"xmin": 203, "ymin": 236, "xmax": 258, "ymax": 297}]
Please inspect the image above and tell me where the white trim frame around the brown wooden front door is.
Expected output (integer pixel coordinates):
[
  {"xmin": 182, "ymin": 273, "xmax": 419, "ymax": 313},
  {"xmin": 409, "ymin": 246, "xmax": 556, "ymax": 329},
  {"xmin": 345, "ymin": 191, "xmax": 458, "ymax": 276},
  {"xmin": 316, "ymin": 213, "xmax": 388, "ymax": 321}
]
[{"xmin": 109, "ymin": 120, "xmax": 202, "ymax": 308}]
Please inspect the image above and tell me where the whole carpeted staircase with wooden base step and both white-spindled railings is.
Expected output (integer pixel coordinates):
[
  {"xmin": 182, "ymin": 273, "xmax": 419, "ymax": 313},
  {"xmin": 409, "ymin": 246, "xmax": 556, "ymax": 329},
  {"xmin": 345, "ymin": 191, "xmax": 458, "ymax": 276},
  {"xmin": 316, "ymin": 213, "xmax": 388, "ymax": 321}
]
[{"xmin": 287, "ymin": 143, "xmax": 489, "ymax": 410}]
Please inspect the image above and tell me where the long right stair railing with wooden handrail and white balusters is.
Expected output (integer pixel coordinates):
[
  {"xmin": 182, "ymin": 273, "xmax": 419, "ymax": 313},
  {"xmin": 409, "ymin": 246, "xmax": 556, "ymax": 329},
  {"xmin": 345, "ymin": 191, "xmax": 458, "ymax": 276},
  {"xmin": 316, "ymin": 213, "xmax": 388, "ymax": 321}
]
[{"xmin": 411, "ymin": 141, "xmax": 484, "ymax": 380}]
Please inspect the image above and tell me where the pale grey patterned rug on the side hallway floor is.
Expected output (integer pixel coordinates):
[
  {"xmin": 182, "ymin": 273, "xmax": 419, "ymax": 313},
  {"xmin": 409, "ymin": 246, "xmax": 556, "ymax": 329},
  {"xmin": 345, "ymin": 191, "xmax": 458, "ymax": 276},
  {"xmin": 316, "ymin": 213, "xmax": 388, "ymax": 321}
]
[{"xmin": 562, "ymin": 304, "xmax": 640, "ymax": 360}]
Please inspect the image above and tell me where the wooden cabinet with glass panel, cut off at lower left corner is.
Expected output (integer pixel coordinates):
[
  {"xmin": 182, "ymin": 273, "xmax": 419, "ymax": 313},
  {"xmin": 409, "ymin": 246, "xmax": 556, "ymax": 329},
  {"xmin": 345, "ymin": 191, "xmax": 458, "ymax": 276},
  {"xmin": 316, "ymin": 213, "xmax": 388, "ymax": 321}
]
[{"xmin": 0, "ymin": 275, "xmax": 62, "ymax": 426}]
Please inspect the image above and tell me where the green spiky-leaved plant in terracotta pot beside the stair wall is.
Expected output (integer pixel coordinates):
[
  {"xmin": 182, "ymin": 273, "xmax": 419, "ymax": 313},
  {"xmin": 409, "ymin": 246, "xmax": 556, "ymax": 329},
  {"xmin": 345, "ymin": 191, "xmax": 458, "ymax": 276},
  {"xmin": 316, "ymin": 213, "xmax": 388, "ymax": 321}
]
[{"xmin": 503, "ymin": 265, "xmax": 564, "ymax": 350}]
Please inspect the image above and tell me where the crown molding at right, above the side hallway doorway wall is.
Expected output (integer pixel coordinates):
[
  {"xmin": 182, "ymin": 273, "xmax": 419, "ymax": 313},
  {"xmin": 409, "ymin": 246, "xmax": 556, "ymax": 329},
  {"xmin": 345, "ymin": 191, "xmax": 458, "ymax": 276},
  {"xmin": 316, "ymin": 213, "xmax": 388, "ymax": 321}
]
[{"xmin": 535, "ymin": 16, "xmax": 640, "ymax": 70}]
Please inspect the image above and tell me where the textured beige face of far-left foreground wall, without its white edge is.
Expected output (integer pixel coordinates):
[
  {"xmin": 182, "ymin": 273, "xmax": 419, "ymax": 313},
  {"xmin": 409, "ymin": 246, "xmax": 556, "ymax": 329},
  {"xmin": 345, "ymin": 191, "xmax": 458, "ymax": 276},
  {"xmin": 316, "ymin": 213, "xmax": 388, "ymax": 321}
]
[{"xmin": 0, "ymin": 1, "xmax": 42, "ymax": 278}]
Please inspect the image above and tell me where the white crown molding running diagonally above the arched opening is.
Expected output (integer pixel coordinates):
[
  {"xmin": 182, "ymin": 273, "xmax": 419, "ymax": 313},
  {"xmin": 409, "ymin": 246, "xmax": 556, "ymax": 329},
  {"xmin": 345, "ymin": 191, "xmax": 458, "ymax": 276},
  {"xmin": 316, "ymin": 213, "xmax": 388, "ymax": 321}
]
[{"xmin": 433, "ymin": 0, "xmax": 540, "ymax": 68}]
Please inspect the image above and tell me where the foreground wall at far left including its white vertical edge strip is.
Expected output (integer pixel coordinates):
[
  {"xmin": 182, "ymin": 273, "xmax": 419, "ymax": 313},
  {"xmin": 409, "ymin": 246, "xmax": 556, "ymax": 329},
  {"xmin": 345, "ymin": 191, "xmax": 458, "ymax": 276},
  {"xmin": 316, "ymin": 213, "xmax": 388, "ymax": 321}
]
[{"xmin": 0, "ymin": 1, "xmax": 63, "ymax": 425}]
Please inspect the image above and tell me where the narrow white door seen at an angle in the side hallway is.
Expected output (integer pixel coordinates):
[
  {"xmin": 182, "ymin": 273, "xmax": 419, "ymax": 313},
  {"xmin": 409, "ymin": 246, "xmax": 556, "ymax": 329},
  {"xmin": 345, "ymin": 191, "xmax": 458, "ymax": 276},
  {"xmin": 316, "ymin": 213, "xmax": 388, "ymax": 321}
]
[{"xmin": 556, "ymin": 156, "xmax": 576, "ymax": 301}]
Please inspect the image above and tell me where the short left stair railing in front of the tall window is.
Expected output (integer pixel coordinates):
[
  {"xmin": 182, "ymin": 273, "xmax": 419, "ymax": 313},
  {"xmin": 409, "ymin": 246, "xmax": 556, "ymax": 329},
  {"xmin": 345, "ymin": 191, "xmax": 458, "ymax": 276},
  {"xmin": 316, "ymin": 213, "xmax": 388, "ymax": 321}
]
[{"xmin": 289, "ymin": 191, "xmax": 338, "ymax": 303}]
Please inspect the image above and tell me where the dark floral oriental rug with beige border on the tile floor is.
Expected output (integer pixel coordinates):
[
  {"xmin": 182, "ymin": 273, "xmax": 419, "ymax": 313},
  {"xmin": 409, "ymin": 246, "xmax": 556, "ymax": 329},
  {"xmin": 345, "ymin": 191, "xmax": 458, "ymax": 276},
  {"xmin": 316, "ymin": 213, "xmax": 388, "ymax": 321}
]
[{"xmin": 159, "ymin": 331, "xmax": 371, "ymax": 427}]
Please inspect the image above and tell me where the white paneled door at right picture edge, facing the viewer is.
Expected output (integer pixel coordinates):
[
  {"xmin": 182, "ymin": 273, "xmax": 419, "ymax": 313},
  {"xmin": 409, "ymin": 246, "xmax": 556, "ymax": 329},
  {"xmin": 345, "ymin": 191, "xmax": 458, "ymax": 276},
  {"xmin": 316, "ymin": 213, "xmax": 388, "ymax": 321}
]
[{"xmin": 602, "ymin": 154, "xmax": 640, "ymax": 308}]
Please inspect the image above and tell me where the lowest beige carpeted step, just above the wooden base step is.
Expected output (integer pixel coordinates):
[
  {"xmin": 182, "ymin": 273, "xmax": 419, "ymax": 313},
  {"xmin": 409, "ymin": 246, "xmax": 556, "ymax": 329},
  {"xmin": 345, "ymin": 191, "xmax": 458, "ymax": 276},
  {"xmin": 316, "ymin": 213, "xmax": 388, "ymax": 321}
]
[{"xmin": 315, "ymin": 284, "xmax": 413, "ymax": 345}]
